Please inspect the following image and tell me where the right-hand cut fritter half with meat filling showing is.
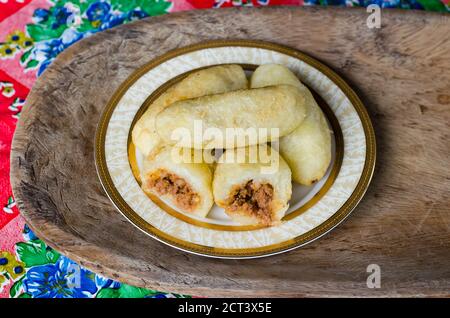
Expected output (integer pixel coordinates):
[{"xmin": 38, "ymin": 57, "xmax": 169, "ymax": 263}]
[{"xmin": 213, "ymin": 144, "xmax": 292, "ymax": 226}]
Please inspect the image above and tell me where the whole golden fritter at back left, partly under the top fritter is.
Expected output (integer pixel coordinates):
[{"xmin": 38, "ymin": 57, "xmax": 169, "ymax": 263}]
[{"xmin": 132, "ymin": 65, "xmax": 248, "ymax": 156}]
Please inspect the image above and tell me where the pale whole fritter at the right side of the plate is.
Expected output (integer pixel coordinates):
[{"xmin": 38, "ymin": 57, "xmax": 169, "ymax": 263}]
[{"xmin": 251, "ymin": 64, "xmax": 331, "ymax": 185}]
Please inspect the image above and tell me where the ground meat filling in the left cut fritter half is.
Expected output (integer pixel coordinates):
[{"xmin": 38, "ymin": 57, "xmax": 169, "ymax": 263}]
[{"xmin": 147, "ymin": 170, "xmax": 200, "ymax": 211}]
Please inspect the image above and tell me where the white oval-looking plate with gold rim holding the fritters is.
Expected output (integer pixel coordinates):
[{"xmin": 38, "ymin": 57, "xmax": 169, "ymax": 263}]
[{"xmin": 96, "ymin": 41, "xmax": 375, "ymax": 258}]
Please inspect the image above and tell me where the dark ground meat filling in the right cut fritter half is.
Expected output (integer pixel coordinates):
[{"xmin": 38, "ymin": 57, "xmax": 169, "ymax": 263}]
[{"xmin": 227, "ymin": 180, "xmax": 273, "ymax": 223}]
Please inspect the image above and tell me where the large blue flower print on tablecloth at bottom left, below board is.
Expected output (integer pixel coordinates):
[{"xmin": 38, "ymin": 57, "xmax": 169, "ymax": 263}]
[{"xmin": 23, "ymin": 256, "xmax": 97, "ymax": 298}]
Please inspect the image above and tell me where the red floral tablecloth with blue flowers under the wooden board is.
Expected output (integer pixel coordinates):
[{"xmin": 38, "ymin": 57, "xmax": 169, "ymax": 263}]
[{"xmin": 0, "ymin": 0, "xmax": 450, "ymax": 298}]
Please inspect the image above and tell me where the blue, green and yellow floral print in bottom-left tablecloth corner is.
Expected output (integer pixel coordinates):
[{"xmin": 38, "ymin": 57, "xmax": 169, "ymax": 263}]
[{"xmin": 0, "ymin": 226, "xmax": 186, "ymax": 298}]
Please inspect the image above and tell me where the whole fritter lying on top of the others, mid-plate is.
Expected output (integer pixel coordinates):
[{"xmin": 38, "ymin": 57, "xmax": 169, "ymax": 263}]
[{"xmin": 156, "ymin": 85, "xmax": 306, "ymax": 149}]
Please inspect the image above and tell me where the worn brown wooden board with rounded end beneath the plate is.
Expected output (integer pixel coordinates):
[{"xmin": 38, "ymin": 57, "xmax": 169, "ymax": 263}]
[{"xmin": 11, "ymin": 7, "xmax": 450, "ymax": 296}]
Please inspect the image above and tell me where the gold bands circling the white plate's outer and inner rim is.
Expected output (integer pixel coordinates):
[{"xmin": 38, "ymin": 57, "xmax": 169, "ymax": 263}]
[{"xmin": 95, "ymin": 40, "xmax": 376, "ymax": 258}]
